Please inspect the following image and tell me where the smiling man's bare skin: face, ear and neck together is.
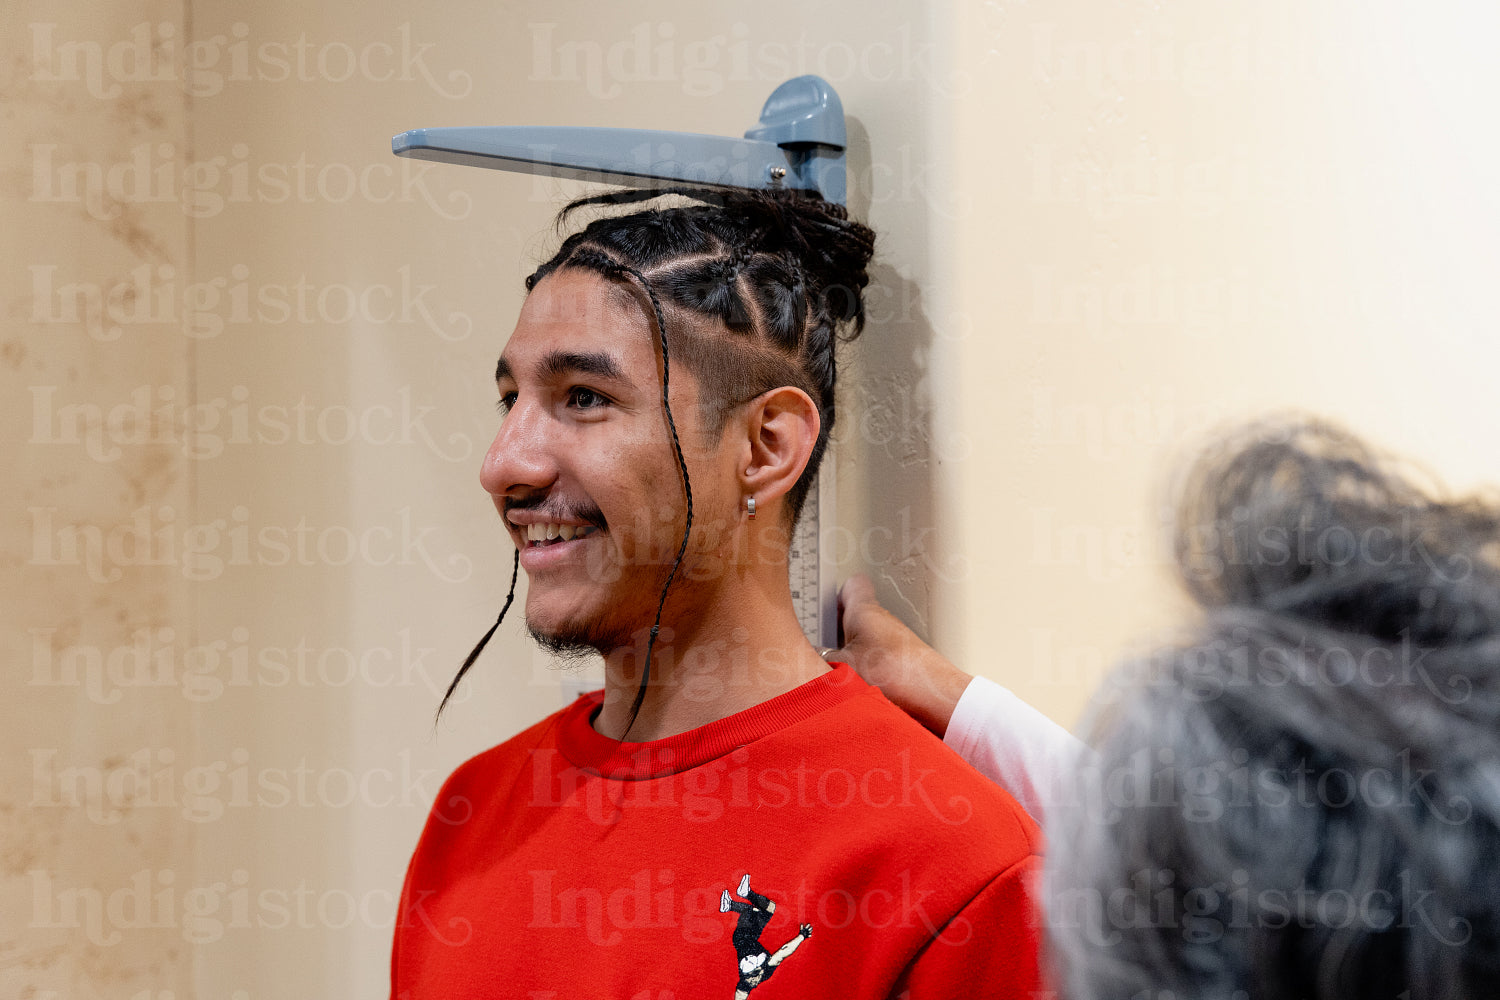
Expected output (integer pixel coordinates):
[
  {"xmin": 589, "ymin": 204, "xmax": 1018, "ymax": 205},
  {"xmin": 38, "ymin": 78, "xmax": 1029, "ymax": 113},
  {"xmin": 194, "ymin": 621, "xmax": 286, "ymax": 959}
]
[{"xmin": 480, "ymin": 267, "xmax": 828, "ymax": 738}]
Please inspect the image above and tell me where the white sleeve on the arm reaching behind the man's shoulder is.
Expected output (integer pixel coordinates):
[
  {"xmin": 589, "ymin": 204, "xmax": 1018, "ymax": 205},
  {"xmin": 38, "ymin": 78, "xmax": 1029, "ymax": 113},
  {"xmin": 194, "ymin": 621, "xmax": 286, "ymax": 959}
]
[{"xmin": 944, "ymin": 678, "xmax": 1083, "ymax": 823}]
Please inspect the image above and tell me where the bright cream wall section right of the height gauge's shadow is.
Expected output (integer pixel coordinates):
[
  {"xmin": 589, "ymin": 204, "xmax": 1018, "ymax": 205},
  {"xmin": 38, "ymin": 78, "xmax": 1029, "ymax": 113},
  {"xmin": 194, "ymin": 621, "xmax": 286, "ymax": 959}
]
[{"xmin": 938, "ymin": 0, "xmax": 1500, "ymax": 721}]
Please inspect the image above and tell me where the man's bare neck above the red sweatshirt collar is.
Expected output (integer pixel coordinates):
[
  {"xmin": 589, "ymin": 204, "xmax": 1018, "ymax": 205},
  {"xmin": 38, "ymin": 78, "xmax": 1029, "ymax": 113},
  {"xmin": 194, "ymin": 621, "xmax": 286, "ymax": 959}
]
[{"xmin": 594, "ymin": 588, "xmax": 828, "ymax": 742}]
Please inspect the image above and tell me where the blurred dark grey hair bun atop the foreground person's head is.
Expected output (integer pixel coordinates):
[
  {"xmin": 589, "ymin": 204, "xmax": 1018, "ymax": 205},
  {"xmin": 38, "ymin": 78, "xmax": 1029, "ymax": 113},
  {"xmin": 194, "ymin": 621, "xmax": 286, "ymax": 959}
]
[{"xmin": 1176, "ymin": 418, "xmax": 1500, "ymax": 645}]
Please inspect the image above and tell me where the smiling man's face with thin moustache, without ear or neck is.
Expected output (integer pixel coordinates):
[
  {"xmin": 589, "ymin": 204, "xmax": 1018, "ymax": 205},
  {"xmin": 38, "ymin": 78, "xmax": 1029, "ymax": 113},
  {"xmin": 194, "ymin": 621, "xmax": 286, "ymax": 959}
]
[{"xmin": 480, "ymin": 268, "xmax": 722, "ymax": 652}]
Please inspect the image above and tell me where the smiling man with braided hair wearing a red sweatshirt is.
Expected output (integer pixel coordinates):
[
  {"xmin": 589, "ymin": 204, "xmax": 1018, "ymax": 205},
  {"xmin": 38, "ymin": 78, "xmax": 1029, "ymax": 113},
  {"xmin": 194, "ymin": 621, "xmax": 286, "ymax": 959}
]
[{"xmin": 392, "ymin": 190, "xmax": 1041, "ymax": 1000}]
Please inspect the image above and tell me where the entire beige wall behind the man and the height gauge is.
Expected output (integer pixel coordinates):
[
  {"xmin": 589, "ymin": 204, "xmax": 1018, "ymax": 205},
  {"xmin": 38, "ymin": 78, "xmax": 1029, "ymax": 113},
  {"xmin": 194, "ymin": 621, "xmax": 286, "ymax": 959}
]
[{"xmin": 11, "ymin": 0, "xmax": 1500, "ymax": 1000}]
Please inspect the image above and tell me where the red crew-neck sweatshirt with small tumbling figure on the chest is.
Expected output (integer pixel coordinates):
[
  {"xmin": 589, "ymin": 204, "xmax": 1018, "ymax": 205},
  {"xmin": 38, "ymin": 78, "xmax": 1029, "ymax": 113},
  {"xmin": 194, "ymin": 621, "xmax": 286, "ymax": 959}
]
[{"xmin": 392, "ymin": 666, "xmax": 1041, "ymax": 1000}]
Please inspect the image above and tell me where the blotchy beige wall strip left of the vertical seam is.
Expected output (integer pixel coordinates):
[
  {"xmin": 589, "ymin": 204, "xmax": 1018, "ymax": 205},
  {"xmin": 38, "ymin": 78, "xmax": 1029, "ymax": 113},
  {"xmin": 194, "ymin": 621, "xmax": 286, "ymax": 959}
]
[{"xmin": 0, "ymin": 0, "xmax": 198, "ymax": 997}]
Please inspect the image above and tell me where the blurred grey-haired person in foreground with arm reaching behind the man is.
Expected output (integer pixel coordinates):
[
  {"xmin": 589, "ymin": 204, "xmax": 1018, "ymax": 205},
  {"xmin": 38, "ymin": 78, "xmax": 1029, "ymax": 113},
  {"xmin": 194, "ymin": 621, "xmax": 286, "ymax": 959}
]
[{"xmin": 843, "ymin": 420, "xmax": 1500, "ymax": 1000}]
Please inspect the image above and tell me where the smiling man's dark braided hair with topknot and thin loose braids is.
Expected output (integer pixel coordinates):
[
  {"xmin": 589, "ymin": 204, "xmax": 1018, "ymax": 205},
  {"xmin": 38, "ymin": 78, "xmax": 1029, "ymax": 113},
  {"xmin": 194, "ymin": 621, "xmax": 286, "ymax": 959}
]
[{"xmin": 438, "ymin": 187, "xmax": 875, "ymax": 735}]
